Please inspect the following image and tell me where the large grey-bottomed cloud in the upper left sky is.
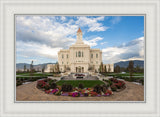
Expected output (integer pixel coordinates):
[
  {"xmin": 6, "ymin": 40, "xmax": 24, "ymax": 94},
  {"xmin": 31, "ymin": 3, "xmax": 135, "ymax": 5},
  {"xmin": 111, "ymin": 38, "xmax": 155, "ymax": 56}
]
[{"xmin": 16, "ymin": 16, "xmax": 78, "ymax": 48}]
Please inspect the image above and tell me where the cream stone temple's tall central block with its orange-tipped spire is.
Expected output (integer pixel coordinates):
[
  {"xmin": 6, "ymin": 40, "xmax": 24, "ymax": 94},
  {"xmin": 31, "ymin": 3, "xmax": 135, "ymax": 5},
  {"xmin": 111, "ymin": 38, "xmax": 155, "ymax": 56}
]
[{"xmin": 58, "ymin": 28, "xmax": 113, "ymax": 73}]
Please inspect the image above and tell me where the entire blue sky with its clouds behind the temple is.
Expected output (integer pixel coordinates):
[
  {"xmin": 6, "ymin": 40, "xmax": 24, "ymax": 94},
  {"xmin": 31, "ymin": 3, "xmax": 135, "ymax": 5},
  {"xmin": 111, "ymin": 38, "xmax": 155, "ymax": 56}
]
[{"xmin": 16, "ymin": 15, "xmax": 144, "ymax": 64}]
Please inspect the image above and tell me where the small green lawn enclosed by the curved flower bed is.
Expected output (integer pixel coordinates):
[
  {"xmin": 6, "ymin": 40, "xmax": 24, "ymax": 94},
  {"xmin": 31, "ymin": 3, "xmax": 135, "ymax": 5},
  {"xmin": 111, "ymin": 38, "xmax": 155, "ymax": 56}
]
[{"xmin": 56, "ymin": 80, "xmax": 104, "ymax": 87}]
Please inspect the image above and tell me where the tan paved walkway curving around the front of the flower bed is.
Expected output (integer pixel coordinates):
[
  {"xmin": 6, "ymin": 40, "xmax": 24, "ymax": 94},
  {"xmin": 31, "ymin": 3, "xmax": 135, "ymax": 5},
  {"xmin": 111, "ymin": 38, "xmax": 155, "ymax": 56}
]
[{"xmin": 16, "ymin": 81, "xmax": 144, "ymax": 101}]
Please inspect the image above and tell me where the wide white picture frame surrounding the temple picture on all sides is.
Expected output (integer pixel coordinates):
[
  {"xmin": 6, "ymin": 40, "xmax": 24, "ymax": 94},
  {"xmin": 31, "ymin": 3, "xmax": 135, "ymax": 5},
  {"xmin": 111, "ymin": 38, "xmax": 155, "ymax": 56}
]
[{"xmin": 0, "ymin": 0, "xmax": 160, "ymax": 117}]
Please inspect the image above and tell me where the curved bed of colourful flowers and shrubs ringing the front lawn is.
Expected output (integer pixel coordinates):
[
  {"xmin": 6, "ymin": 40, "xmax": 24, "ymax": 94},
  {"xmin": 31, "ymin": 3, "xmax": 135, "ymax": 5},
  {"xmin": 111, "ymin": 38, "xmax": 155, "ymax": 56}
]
[{"xmin": 37, "ymin": 78, "xmax": 126, "ymax": 97}]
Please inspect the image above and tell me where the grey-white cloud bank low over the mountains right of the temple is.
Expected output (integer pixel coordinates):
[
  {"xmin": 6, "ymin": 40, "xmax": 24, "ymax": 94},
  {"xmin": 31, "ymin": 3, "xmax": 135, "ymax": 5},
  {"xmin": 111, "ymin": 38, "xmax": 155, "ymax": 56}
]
[{"xmin": 102, "ymin": 37, "xmax": 144, "ymax": 63}]
